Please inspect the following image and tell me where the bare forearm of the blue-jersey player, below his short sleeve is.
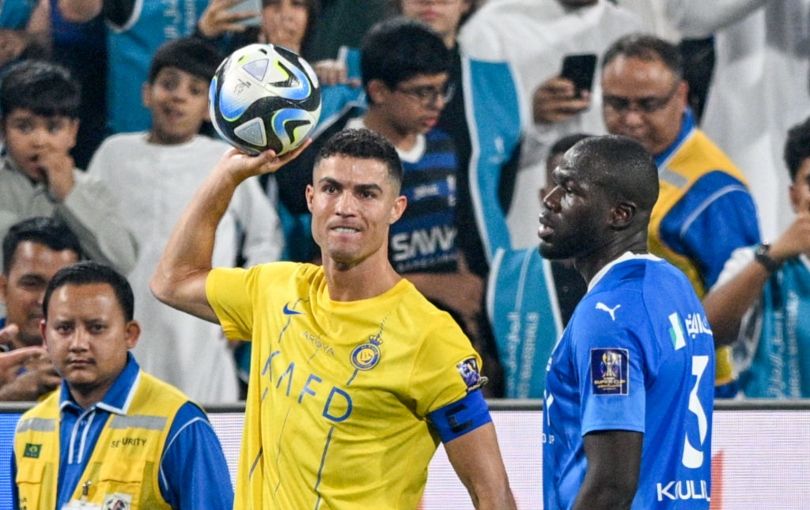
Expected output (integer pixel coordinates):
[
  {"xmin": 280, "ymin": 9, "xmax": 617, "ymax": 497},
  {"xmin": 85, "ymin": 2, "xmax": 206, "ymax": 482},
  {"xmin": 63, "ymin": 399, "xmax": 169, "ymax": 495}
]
[{"xmin": 574, "ymin": 430, "xmax": 644, "ymax": 510}]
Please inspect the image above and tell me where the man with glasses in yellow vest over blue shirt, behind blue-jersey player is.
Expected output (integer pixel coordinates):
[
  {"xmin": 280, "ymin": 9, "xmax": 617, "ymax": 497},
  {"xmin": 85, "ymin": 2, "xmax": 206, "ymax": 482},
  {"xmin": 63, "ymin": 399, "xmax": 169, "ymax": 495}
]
[{"xmin": 602, "ymin": 34, "xmax": 760, "ymax": 396}]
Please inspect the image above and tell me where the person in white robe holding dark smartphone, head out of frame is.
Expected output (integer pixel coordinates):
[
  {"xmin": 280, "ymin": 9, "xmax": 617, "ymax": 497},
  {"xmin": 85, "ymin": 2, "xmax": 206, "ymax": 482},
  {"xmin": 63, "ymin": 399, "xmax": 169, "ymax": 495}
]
[{"xmin": 459, "ymin": 0, "xmax": 641, "ymax": 248}]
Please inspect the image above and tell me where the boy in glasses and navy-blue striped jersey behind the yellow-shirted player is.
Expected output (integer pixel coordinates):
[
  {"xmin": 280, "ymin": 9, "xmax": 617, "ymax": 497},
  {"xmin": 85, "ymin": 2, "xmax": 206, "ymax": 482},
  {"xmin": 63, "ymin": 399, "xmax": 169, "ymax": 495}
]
[{"xmin": 275, "ymin": 17, "xmax": 490, "ymax": 350}]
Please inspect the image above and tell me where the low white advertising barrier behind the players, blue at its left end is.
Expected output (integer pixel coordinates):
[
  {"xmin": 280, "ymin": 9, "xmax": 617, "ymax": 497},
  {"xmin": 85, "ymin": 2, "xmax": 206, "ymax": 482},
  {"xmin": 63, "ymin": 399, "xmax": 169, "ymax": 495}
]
[{"xmin": 0, "ymin": 400, "xmax": 810, "ymax": 510}]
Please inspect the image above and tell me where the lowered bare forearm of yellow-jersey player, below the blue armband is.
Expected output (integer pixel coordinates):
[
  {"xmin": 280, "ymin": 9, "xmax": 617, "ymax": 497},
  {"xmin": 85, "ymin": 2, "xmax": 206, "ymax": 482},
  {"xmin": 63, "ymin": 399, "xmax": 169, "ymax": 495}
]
[{"xmin": 444, "ymin": 423, "xmax": 517, "ymax": 510}]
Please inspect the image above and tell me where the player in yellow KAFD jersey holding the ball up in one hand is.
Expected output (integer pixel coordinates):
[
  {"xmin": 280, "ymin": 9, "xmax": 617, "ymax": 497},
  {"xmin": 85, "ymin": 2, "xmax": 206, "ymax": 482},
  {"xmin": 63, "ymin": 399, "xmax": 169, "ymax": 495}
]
[{"xmin": 152, "ymin": 129, "xmax": 515, "ymax": 510}]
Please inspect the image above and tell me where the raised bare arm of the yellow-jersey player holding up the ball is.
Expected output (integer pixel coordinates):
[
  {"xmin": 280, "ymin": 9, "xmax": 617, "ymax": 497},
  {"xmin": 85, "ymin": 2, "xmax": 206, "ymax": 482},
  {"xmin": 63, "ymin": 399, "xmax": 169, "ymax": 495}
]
[{"xmin": 150, "ymin": 143, "xmax": 308, "ymax": 322}]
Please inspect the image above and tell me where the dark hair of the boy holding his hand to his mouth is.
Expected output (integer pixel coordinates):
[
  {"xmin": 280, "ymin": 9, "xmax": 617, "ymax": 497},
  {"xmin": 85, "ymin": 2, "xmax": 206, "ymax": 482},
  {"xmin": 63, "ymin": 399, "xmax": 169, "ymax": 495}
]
[{"xmin": 0, "ymin": 60, "xmax": 82, "ymax": 120}]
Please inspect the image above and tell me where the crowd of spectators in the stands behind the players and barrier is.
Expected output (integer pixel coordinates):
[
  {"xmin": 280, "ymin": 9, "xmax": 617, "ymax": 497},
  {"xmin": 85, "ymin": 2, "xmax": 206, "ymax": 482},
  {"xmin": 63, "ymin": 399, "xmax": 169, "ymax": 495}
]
[{"xmin": 0, "ymin": 0, "xmax": 810, "ymax": 403}]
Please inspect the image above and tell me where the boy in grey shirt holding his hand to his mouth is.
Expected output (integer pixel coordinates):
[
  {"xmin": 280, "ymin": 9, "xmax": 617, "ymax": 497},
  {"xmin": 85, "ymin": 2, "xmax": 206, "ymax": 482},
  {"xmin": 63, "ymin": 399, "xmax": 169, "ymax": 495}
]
[{"xmin": 0, "ymin": 60, "xmax": 137, "ymax": 274}]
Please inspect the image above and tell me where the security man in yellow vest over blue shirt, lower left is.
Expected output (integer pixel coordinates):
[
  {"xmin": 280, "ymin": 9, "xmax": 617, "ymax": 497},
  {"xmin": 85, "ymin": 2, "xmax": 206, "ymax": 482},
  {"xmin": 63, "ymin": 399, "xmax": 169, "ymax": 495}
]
[{"xmin": 11, "ymin": 262, "xmax": 233, "ymax": 510}]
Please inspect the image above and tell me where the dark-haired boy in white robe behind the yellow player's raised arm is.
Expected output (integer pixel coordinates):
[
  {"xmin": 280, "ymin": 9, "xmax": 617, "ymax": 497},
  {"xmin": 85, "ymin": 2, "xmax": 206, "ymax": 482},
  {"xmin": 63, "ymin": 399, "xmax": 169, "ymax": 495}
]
[{"xmin": 89, "ymin": 38, "xmax": 283, "ymax": 403}]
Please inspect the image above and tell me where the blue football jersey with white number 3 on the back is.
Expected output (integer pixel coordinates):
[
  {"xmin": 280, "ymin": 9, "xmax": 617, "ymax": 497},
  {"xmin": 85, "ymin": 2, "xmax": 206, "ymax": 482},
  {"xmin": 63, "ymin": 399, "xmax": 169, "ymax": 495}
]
[{"xmin": 542, "ymin": 255, "xmax": 714, "ymax": 509}]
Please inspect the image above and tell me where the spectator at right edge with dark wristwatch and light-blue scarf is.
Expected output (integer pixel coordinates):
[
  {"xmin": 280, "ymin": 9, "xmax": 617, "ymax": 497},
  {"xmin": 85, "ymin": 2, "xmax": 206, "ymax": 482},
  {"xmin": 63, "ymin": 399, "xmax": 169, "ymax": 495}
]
[{"xmin": 704, "ymin": 119, "xmax": 810, "ymax": 399}]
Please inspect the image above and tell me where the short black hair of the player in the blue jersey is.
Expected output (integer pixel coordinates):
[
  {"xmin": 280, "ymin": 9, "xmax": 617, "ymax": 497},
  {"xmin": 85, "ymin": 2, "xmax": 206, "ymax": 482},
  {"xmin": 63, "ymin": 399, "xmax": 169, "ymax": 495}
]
[{"xmin": 571, "ymin": 135, "xmax": 659, "ymax": 215}]
